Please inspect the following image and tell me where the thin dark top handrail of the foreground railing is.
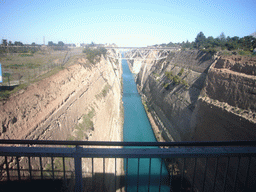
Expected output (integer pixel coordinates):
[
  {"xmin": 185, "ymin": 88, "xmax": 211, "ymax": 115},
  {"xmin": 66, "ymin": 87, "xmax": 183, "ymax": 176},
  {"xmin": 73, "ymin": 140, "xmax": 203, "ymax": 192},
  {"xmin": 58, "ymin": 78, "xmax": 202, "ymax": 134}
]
[{"xmin": 0, "ymin": 139, "xmax": 256, "ymax": 147}]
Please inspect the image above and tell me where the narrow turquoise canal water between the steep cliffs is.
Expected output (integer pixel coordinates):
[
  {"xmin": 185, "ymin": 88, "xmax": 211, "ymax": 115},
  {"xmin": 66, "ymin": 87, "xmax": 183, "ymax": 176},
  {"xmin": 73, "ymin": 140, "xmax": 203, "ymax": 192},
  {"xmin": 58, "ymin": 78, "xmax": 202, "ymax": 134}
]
[{"xmin": 122, "ymin": 60, "xmax": 170, "ymax": 191}]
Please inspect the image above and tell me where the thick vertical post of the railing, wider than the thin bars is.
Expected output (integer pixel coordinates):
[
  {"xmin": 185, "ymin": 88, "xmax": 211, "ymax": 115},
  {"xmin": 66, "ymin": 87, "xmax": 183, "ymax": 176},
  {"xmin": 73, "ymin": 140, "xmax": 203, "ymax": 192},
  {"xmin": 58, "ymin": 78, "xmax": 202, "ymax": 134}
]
[{"xmin": 74, "ymin": 146, "xmax": 83, "ymax": 192}]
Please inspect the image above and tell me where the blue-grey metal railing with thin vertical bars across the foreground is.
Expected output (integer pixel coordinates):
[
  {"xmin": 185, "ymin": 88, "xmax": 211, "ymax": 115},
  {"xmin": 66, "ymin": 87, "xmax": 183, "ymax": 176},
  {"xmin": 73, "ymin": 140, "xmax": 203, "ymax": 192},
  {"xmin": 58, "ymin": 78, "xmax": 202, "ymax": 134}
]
[{"xmin": 0, "ymin": 139, "xmax": 256, "ymax": 192}]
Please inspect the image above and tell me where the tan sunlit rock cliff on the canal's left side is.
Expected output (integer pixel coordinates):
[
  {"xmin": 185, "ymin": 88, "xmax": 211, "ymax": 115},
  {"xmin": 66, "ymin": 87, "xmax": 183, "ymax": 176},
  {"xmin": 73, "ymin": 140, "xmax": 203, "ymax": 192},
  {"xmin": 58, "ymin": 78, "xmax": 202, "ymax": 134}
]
[{"xmin": 0, "ymin": 56, "xmax": 123, "ymax": 190}]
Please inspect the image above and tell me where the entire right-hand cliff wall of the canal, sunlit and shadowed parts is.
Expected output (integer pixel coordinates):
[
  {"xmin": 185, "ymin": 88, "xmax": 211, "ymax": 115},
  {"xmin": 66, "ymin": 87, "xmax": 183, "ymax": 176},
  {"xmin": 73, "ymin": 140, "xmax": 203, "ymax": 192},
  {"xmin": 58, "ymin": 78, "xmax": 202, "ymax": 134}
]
[{"xmin": 129, "ymin": 50, "xmax": 256, "ymax": 191}]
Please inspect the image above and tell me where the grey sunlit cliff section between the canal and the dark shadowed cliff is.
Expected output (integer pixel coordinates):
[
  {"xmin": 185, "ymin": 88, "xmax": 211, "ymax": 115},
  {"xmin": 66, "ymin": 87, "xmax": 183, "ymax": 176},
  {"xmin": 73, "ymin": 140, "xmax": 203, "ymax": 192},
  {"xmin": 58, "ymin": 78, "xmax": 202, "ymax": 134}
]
[{"xmin": 136, "ymin": 51, "xmax": 215, "ymax": 141}]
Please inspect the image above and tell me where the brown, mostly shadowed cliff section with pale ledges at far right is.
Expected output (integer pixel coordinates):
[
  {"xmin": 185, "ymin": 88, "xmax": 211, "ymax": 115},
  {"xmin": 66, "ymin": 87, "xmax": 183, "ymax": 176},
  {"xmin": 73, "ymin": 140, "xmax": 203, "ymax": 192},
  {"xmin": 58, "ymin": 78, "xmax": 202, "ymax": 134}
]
[{"xmin": 191, "ymin": 56, "xmax": 256, "ymax": 141}]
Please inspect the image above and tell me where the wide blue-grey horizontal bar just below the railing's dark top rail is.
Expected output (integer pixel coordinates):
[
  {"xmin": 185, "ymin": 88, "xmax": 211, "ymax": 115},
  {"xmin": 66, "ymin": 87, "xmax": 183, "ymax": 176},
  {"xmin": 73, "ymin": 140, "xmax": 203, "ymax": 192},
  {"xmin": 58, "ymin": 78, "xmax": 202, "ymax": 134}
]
[{"xmin": 0, "ymin": 147, "xmax": 256, "ymax": 158}]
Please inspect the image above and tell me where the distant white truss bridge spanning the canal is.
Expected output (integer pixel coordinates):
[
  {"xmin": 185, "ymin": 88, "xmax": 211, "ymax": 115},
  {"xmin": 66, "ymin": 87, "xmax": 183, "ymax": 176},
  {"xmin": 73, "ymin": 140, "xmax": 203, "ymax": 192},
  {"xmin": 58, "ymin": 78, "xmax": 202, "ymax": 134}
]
[{"xmin": 105, "ymin": 47, "xmax": 180, "ymax": 61}]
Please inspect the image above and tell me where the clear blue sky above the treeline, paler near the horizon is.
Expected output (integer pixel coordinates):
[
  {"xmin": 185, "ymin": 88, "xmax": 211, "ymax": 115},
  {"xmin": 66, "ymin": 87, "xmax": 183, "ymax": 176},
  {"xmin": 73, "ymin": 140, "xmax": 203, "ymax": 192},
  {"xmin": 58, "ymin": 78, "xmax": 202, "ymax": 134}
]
[{"xmin": 0, "ymin": 0, "xmax": 256, "ymax": 46}]
